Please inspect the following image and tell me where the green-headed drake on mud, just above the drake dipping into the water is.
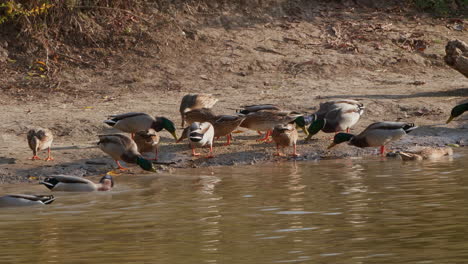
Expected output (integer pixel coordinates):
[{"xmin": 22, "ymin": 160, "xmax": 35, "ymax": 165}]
[{"xmin": 104, "ymin": 112, "xmax": 177, "ymax": 140}]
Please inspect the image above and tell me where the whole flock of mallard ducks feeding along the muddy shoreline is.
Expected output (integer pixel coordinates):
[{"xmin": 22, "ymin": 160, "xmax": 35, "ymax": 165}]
[{"xmin": 0, "ymin": 94, "xmax": 468, "ymax": 207}]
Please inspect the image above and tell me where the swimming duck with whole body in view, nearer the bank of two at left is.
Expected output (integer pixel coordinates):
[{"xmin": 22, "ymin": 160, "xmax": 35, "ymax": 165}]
[{"xmin": 39, "ymin": 175, "xmax": 114, "ymax": 192}]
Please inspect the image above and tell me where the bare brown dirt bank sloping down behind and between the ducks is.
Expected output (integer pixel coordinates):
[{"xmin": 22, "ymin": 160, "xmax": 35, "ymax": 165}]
[{"xmin": 0, "ymin": 2, "xmax": 468, "ymax": 182}]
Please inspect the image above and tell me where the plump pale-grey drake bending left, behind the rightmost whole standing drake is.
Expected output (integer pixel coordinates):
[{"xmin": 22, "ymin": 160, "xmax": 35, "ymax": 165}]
[{"xmin": 306, "ymin": 101, "xmax": 364, "ymax": 141}]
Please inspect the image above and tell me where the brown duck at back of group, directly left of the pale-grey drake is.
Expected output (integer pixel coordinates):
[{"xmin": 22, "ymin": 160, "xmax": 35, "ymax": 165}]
[{"xmin": 240, "ymin": 110, "xmax": 305, "ymax": 141}]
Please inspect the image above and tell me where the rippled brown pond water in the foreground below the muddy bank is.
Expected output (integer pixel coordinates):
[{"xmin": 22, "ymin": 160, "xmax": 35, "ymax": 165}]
[{"xmin": 0, "ymin": 149, "xmax": 468, "ymax": 264}]
